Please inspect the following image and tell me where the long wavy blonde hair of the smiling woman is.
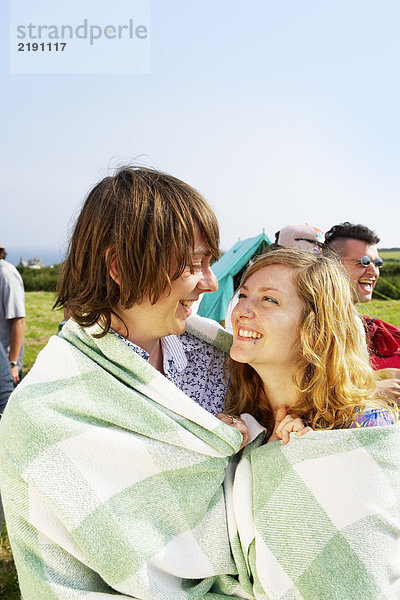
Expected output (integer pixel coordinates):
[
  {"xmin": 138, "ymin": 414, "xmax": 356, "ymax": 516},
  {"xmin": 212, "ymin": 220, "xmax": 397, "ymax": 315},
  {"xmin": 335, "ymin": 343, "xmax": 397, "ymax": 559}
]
[{"xmin": 226, "ymin": 248, "xmax": 398, "ymax": 429}]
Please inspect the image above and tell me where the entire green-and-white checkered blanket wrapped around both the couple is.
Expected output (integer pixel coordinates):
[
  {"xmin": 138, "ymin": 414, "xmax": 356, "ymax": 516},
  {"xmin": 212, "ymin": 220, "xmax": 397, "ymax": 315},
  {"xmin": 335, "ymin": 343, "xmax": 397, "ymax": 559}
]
[{"xmin": 0, "ymin": 319, "xmax": 400, "ymax": 600}]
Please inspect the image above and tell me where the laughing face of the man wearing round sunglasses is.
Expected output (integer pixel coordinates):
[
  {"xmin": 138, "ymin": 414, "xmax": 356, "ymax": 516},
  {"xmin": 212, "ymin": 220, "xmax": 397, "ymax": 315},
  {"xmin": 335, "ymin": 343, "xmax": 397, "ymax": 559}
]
[{"xmin": 341, "ymin": 239, "xmax": 379, "ymax": 302}]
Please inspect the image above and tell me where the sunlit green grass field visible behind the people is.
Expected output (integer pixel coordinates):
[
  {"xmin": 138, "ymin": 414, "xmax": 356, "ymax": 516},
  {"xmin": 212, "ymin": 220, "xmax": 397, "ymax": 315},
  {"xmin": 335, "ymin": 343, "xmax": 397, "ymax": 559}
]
[{"xmin": 0, "ymin": 292, "xmax": 400, "ymax": 600}]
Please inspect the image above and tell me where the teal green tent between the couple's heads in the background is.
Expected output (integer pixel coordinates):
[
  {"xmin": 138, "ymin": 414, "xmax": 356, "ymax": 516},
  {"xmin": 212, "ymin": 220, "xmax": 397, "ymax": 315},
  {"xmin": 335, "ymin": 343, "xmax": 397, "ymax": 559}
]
[{"xmin": 198, "ymin": 232, "xmax": 271, "ymax": 322}]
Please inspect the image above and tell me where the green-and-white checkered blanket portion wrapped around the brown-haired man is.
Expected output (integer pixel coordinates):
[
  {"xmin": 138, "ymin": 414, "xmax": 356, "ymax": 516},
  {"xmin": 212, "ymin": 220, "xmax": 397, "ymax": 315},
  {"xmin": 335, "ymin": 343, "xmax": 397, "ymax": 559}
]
[{"xmin": 0, "ymin": 319, "xmax": 250, "ymax": 600}]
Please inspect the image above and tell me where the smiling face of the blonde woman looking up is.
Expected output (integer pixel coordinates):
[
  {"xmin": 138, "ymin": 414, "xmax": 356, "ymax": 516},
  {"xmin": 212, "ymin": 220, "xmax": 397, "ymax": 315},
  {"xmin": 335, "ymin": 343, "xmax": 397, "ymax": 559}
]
[{"xmin": 230, "ymin": 264, "xmax": 304, "ymax": 372}]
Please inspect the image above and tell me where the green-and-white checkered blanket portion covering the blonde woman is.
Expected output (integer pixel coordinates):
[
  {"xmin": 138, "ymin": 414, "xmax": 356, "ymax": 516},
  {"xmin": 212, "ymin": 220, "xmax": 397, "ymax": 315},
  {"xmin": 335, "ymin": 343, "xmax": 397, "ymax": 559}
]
[{"xmin": 225, "ymin": 424, "xmax": 400, "ymax": 600}]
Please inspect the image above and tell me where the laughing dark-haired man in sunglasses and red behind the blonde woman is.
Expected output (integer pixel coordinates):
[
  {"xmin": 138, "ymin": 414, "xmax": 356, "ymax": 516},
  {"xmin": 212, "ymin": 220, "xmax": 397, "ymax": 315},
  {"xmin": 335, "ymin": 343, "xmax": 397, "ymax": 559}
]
[{"xmin": 325, "ymin": 222, "xmax": 400, "ymax": 400}]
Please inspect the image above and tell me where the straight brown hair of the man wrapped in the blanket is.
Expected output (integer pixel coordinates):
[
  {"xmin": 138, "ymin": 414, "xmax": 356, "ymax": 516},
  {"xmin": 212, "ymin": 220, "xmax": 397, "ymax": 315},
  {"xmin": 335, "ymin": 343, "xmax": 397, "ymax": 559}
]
[{"xmin": 54, "ymin": 166, "xmax": 219, "ymax": 333}]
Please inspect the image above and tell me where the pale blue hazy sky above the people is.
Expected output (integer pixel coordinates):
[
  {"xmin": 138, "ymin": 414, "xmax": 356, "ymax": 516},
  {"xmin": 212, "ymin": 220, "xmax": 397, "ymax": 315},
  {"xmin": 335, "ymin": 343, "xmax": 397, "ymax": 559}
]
[{"xmin": 0, "ymin": 0, "xmax": 400, "ymax": 263}]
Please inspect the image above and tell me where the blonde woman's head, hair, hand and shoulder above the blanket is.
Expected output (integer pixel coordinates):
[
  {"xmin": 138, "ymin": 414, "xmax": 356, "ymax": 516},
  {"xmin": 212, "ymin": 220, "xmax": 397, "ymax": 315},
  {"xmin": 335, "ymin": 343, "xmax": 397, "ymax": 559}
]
[{"xmin": 227, "ymin": 248, "xmax": 397, "ymax": 441}]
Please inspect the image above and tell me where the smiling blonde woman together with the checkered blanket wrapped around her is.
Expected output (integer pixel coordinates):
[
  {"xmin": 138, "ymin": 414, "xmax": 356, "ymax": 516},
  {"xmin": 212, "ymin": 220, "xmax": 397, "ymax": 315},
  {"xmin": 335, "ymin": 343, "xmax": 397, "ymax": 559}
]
[{"xmin": 220, "ymin": 248, "xmax": 400, "ymax": 600}]
